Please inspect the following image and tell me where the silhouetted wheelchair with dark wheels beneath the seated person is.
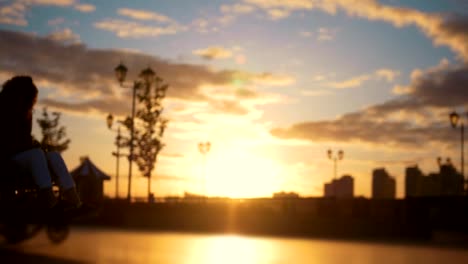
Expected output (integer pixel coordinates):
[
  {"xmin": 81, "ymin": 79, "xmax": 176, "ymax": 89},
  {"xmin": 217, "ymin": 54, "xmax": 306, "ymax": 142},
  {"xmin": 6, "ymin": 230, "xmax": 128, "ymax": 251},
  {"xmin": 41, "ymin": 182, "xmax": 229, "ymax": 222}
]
[{"xmin": 0, "ymin": 161, "xmax": 70, "ymax": 244}]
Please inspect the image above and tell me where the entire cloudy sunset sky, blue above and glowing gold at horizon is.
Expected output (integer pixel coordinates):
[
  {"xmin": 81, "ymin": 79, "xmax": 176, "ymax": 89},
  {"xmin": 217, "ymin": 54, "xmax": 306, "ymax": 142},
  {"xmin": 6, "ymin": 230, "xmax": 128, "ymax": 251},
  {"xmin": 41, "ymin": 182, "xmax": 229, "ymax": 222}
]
[{"xmin": 0, "ymin": 0, "xmax": 468, "ymax": 197}]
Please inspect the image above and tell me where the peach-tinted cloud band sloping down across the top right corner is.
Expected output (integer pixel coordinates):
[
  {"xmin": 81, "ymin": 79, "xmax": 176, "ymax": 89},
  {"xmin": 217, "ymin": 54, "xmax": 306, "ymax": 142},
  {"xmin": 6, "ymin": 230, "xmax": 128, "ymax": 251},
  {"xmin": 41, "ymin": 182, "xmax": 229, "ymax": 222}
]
[{"xmin": 239, "ymin": 0, "xmax": 468, "ymax": 61}]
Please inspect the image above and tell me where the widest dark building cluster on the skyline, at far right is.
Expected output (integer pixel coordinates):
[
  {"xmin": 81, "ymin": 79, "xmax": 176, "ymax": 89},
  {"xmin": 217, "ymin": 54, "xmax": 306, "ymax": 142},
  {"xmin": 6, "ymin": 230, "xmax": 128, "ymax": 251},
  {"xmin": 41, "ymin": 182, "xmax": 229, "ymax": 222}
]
[{"xmin": 405, "ymin": 162, "xmax": 463, "ymax": 197}]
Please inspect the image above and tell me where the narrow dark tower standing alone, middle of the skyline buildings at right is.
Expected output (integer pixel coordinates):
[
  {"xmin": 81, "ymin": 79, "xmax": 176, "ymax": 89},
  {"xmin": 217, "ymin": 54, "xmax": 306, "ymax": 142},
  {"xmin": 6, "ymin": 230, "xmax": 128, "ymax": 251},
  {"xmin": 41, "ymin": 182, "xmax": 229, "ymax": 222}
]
[{"xmin": 372, "ymin": 168, "xmax": 396, "ymax": 199}]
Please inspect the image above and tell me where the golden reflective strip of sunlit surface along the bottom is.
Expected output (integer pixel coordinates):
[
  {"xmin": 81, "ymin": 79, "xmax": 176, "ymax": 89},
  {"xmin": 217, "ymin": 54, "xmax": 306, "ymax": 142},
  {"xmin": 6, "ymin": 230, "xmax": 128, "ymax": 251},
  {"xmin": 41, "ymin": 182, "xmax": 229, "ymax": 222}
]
[{"xmin": 6, "ymin": 228, "xmax": 468, "ymax": 264}]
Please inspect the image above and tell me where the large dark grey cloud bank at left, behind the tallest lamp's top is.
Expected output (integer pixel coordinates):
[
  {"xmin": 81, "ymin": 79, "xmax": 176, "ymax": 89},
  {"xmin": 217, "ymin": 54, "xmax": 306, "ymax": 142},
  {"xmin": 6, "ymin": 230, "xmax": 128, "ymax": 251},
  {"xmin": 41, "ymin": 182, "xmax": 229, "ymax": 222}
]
[{"xmin": 0, "ymin": 30, "xmax": 227, "ymax": 112}]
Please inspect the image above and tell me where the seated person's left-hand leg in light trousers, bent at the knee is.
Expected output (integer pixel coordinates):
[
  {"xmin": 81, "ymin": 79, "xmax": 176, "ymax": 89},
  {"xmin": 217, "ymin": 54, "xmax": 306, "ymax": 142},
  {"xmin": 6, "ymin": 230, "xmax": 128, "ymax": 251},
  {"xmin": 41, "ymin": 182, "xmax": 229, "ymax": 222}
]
[{"xmin": 12, "ymin": 148, "xmax": 57, "ymax": 208}]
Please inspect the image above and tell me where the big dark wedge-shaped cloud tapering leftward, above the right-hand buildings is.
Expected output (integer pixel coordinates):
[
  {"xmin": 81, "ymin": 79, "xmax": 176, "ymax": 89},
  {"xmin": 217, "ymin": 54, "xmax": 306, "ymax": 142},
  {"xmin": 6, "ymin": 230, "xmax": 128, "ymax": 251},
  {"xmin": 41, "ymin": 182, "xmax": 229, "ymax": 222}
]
[{"xmin": 271, "ymin": 60, "xmax": 468, "ymax": 149}]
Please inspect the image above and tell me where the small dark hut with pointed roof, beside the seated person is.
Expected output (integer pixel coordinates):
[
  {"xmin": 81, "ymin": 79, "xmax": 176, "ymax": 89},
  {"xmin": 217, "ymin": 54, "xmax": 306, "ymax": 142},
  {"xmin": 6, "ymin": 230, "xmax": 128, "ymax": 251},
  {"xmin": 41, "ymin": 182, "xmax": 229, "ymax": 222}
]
[{"xmin": 70, "ymin": 157, "xmax": 110, "ymax": 205}]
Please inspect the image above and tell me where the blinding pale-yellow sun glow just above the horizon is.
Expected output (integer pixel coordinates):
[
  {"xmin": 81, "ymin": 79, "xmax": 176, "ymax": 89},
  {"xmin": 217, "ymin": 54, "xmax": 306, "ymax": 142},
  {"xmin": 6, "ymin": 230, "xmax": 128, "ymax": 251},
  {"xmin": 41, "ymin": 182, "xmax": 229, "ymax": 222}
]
[{"xmin": 200, "ymin": 150, "xmax": 281, "ymax": 198}]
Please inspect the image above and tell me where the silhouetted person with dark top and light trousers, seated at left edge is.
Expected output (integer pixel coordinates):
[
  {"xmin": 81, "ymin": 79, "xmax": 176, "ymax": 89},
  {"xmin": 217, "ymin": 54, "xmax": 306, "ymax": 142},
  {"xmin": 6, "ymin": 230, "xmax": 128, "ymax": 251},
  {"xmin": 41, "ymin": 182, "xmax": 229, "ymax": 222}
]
[{"xmin": 0, "ymin": 76, "xmax": 81, "ymax": 208}]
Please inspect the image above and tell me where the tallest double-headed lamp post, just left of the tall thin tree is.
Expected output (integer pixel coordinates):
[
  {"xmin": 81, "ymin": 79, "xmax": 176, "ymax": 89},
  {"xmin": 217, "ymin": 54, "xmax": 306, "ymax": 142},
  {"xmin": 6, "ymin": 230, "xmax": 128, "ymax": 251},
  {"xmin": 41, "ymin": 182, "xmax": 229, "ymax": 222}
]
[{"xmin": 114, "ymin": 63, "xmax": 156, "ymax": 202}]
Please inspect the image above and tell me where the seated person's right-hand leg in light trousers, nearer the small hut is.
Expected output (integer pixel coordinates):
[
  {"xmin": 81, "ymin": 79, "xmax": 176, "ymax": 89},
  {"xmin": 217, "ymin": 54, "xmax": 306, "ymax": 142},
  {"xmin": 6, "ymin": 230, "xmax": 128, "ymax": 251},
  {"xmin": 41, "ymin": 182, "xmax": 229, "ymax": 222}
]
[{"xmin": 47, "ymin": 151, "xmax": 81, "ymax": 206}]
